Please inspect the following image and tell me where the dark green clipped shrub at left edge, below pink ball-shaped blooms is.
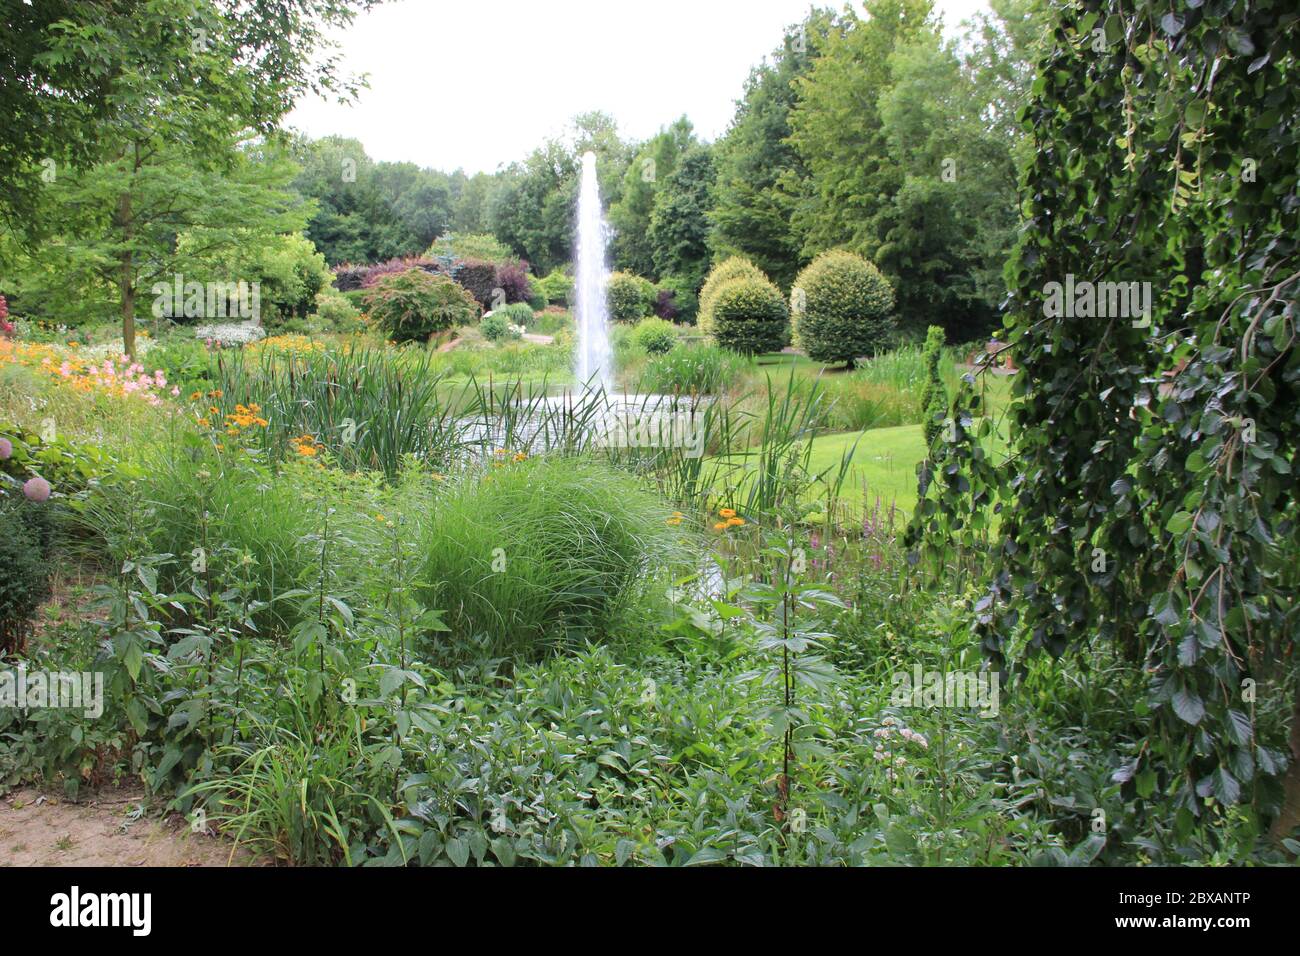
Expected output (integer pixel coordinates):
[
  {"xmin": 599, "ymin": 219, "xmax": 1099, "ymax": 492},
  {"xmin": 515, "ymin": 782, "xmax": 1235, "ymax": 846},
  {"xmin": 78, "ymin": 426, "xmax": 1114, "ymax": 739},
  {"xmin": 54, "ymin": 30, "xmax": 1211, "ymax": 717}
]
[{"xmin": 0, "ymin": 498, "xmax": 51, "ymax": 656}]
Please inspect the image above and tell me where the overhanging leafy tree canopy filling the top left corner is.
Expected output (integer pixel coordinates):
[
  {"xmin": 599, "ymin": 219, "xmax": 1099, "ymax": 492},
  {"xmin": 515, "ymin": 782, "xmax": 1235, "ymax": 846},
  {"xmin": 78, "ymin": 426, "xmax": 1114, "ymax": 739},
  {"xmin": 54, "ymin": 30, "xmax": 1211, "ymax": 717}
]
[{"xmin": 0, "ymin": 0, "xmax": 373, "ymax": 236}]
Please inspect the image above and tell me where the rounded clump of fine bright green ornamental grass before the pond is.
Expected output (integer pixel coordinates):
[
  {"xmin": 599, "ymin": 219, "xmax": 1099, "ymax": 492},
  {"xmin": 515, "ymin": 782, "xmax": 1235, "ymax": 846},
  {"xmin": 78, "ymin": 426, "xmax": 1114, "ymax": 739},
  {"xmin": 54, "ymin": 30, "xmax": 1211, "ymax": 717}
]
[{"xmin": 419, "ymin": 453, "xmax": 683, "ymax": 659}]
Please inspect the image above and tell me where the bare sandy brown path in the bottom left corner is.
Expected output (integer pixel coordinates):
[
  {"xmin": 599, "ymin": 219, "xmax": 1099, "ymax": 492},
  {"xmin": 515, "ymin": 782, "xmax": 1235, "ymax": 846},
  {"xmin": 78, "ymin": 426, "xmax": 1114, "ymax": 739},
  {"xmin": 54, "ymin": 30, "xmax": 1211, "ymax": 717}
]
[{"xmin": 0, "ymin": 787, "xmax": 250, "ymax": 866}]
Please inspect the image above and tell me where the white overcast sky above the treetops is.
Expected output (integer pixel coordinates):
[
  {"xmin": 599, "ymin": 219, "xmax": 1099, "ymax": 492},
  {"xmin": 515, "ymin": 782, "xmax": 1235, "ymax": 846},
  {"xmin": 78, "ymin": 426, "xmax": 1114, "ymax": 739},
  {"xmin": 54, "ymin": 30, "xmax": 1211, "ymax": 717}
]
[{"xmin": 289, "ymin": 0, "xmax": 988, "ymax": 173}]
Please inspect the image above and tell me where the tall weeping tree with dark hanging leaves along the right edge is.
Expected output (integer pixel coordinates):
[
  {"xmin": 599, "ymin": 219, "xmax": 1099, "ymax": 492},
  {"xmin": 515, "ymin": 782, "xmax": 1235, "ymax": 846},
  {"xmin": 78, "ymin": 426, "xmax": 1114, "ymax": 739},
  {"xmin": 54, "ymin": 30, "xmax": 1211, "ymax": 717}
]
[{"xmin": 917, "ymin": 0, "xmax": 1300, "ymax": 858}]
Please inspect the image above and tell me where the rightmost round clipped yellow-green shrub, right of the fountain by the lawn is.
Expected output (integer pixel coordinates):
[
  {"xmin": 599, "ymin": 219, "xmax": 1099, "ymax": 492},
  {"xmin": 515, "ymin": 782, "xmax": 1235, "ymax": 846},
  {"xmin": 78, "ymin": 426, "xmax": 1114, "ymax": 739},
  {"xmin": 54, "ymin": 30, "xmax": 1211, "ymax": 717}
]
[{"xmin": 790, "ymin": 250, "xmax": 894, "ymax": 368}]
